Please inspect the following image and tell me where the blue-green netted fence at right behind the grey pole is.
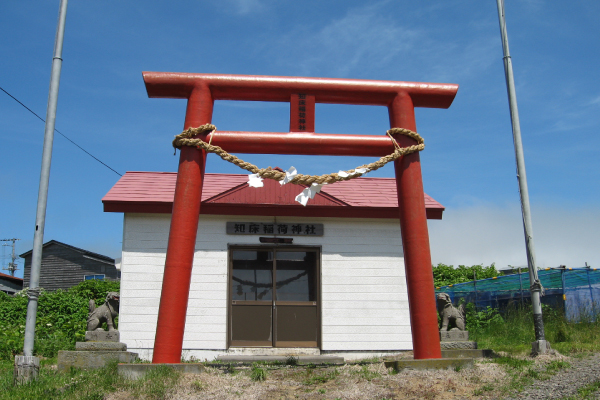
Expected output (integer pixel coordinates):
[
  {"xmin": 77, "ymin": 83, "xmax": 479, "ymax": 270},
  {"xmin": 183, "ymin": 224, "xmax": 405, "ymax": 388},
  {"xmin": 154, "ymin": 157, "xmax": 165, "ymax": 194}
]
[{"xmin": 436, "ymin": 268, "xmax": 600, "ymax": 322}]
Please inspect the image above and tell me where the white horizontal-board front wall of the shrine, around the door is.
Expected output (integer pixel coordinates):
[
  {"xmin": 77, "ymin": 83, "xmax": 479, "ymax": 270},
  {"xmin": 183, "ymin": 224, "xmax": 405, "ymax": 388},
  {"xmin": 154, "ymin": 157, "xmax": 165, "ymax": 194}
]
[{"xmin": 119, "ymin": 214, "xmax": 412, "ymax": 353}]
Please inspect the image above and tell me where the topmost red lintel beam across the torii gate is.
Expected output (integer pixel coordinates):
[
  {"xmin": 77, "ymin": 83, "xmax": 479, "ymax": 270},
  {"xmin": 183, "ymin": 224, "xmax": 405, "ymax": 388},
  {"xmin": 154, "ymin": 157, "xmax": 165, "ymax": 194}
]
[{"xmin": 142, "ymin": 72, "xmax": 458, "ymax": 108}]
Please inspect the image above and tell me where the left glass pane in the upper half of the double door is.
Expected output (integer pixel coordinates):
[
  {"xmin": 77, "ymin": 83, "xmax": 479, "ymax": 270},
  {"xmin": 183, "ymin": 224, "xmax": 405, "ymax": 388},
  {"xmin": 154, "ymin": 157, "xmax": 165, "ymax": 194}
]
[{"xmin": 231, "ymin": 250, "xmax": 273, "ymax": 301}]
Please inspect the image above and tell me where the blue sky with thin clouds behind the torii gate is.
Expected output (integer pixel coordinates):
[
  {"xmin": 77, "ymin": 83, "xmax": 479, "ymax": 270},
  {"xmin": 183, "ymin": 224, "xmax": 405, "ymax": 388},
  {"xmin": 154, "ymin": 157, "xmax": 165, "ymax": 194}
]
[{"xmin": 0, "ymin": 0, "xmax": 600, "ymax": 274}]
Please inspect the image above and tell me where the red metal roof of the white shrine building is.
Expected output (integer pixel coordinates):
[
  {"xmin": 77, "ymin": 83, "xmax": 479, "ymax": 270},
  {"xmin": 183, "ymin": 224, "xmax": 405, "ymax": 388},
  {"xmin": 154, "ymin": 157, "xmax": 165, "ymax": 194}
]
[{"xmin": 102, "ymin": 172, "xmax": 444, "ymax": 219}]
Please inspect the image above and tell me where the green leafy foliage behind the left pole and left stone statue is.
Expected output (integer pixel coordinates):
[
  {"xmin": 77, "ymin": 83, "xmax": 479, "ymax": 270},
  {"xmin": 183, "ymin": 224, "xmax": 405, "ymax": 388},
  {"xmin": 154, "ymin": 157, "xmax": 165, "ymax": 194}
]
[{"xmin": 0, "ymin": 280, "xmax": 120, "ymax": 359}]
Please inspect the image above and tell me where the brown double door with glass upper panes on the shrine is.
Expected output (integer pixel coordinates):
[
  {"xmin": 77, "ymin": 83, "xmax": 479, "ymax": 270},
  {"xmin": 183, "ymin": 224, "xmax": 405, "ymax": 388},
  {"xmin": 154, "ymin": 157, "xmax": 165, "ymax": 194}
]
[{"xmin": 228, "ymin": 247, "xmax": 320, "ymax": 347}]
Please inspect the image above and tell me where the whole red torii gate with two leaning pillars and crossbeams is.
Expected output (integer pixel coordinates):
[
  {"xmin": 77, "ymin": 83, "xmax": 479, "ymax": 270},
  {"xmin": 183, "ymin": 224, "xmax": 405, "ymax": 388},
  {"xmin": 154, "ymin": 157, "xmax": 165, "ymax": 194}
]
[{"xmin": 143, "ymin": 72, "xmax": 458, "ymax": 363}]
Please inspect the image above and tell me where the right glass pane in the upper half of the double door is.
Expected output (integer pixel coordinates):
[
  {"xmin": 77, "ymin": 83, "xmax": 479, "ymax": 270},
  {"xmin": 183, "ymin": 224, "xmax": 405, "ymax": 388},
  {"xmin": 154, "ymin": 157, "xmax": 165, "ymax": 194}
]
[{"xmin": 276, "ymin": 251, "xmax": 317, "ymax": 301}]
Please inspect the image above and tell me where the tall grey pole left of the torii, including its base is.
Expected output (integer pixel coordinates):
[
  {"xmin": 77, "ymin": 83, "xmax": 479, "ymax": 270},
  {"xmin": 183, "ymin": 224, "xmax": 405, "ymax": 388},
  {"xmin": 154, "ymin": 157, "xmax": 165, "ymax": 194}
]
[{"xmin": 14, "ymin": 0, "xmax": 68, "ymax": 383}]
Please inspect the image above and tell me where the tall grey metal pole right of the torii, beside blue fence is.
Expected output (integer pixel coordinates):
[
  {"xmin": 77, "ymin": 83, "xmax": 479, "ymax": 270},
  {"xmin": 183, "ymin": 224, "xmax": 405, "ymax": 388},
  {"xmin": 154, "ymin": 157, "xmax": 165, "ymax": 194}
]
[{"xmin": 496, "ymin": 0, "xmax": 550, "ymax": 354}]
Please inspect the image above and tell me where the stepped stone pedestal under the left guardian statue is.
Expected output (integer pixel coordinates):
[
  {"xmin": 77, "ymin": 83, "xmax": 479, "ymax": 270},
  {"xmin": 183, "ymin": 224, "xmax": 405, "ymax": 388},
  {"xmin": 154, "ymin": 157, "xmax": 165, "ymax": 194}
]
[{"xmin": 58, "ymin": 331, "xmax": 137, "ymax": 371}]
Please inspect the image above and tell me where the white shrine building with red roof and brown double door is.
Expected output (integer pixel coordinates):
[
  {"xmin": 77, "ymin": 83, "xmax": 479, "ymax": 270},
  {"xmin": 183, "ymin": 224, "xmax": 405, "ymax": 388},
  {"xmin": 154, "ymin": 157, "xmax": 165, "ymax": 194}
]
[{"xmin": 102, "ymin": 172, "xmax": 444, "ymax": 360}]
